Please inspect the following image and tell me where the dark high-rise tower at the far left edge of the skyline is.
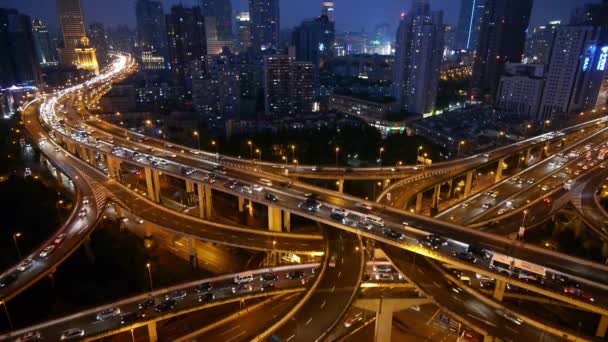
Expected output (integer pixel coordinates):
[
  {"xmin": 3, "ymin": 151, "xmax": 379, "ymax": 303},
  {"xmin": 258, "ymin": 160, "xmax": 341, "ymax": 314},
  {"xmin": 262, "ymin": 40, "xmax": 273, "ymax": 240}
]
[{"xmin": 0, "ymin": 8, "xmax": 41, "ymax": 86}]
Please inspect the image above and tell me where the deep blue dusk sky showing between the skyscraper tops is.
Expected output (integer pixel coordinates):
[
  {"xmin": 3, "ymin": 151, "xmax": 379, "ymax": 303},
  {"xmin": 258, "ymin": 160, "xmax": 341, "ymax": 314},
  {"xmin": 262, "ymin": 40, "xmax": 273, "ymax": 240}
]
[{"xmin": 0, "ymin": 0, "xmax": 597, "ymax": 31}]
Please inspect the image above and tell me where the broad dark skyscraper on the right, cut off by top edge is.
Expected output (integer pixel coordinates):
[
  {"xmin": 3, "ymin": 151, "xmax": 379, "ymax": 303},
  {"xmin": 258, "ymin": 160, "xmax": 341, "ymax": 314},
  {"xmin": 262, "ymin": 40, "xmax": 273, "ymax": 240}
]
[{"xmin": 472, "ymin": 0, "xmax": 533, "ymax": 98}]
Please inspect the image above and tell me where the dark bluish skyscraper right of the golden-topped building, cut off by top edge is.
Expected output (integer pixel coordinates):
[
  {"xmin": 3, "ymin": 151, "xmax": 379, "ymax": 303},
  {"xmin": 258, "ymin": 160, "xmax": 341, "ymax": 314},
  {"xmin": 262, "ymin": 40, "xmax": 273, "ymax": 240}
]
[{"xmin": 135, "ymin": 0, "xmax": 167, "ymax": 57}]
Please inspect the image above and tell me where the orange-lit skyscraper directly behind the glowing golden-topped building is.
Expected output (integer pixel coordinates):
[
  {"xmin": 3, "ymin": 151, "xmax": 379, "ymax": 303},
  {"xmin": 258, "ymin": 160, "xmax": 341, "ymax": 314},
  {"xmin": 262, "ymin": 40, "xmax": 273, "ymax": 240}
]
[{"xmin": 57, "ymin": 0, "xmax": 86, "ymax": 67}]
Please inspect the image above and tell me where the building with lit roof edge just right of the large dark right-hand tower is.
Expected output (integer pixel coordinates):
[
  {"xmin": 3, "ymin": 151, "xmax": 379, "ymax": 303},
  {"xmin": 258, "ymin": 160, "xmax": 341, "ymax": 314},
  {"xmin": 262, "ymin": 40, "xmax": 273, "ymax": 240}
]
[{"xmin": 523, "ymin": 20, "xmax": 561, "ymax": 64}]
